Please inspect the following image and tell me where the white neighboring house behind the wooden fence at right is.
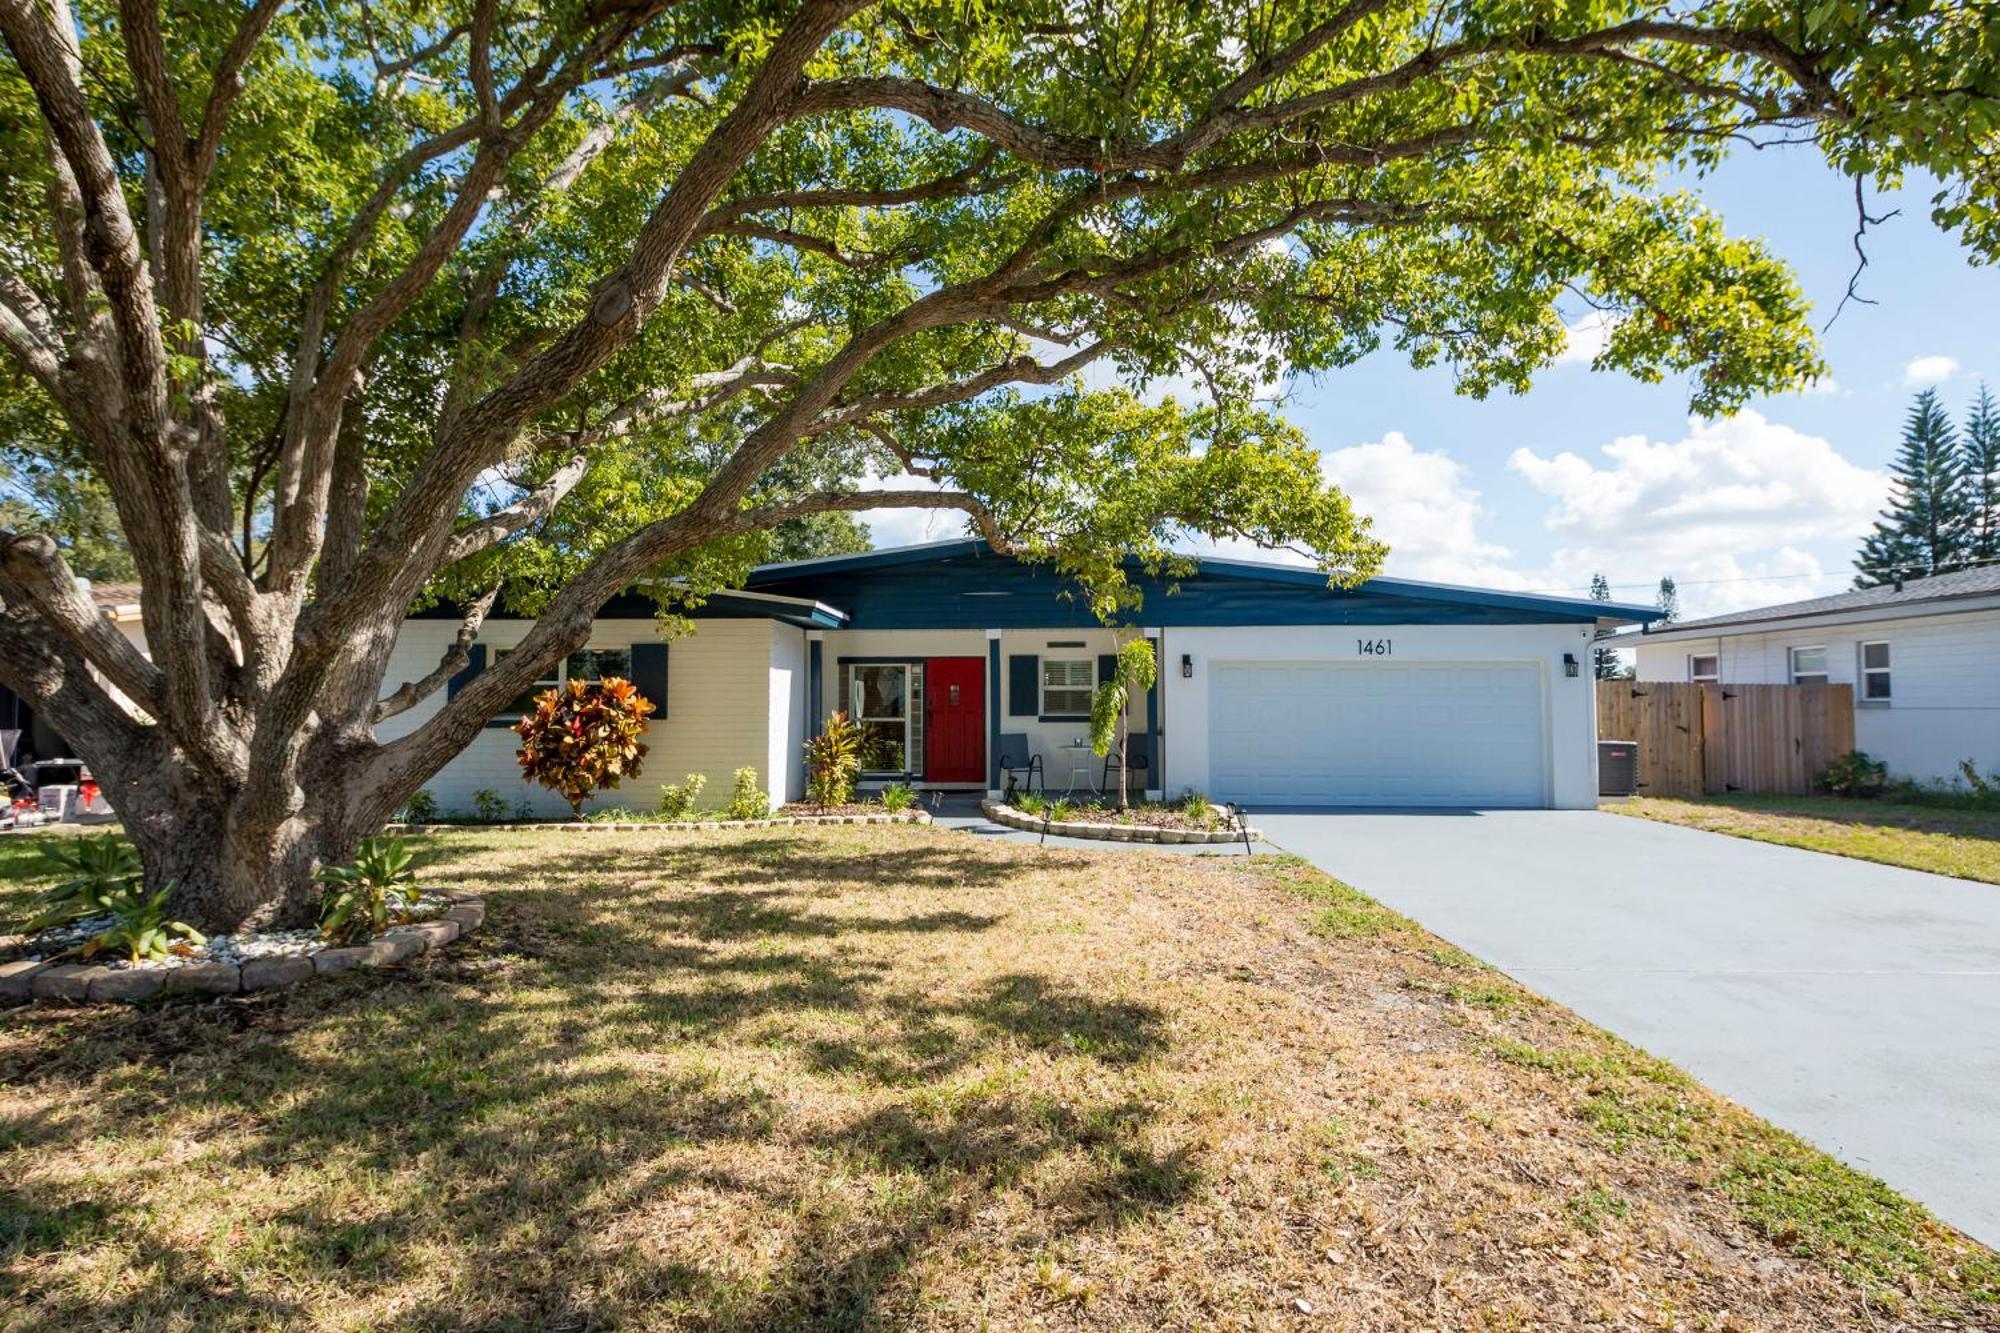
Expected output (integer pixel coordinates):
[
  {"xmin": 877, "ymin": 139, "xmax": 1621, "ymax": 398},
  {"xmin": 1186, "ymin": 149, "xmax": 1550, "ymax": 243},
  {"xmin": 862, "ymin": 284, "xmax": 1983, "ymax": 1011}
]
[{"xmin": 1618, "ymin": 566, "xmax": 2000, "ymax": 783}]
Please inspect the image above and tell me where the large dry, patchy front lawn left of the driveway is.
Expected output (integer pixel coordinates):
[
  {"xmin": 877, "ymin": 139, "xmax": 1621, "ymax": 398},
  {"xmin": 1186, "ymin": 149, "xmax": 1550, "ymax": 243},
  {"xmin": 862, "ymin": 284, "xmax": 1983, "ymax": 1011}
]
[{"xmin": 0, "ymin": 825, "xmax": 2000, "ymax": 1331}]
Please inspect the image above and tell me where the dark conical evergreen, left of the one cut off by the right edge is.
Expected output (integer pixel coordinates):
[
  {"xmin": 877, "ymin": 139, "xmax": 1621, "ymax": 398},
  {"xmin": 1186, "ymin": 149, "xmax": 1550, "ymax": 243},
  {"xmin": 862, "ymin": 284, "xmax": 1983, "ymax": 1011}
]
[{"xmin": 1854, "ymin": 388, "xmax": 1972, "ymax": 588}]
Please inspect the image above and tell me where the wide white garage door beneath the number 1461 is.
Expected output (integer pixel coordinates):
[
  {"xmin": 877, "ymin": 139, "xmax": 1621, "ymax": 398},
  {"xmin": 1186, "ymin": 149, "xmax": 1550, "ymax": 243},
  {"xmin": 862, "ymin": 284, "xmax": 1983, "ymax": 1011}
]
[{"xmin": 1208, "ymin": 662, "xmax": 1548, "ymax": 807}]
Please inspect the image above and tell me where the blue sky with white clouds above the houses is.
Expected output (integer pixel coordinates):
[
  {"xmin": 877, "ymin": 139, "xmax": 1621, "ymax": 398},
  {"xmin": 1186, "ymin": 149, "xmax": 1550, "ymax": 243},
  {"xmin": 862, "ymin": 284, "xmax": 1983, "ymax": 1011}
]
[{"xmin": 870, "ymin": 150, "xmax": 2000, "ymax": 614}]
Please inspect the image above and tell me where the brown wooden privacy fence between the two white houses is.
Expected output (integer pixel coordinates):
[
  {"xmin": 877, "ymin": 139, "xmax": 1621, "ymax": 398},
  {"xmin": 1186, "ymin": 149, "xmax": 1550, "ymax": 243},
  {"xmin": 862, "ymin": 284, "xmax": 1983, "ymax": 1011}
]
[{"xmin": 1598, "ymin": 681, "xmax": 1854, "ymax": 797}]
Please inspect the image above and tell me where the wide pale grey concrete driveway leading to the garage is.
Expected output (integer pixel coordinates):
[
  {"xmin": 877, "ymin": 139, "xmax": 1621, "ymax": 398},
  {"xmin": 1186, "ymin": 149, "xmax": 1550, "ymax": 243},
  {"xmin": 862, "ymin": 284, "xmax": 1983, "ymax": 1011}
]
[{"xmin": 1254, "ymin": 811, "xmax": 2000, "ymax": 1245}]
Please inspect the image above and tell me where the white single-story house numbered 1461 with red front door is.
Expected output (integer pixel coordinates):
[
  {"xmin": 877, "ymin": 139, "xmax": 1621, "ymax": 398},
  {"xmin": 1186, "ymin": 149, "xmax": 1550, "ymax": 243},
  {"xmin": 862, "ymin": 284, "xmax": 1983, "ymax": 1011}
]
[{"xmin": 380, "ymin": 538, "xmax": 1654, "ymax": 813}]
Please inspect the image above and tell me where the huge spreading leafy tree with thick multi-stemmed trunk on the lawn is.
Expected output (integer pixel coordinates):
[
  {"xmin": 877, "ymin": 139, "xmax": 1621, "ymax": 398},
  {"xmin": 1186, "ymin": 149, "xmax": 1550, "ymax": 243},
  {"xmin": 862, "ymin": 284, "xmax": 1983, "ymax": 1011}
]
[{"xmin": 0, "ymin": 0, "xmax": 1996, "ymax": 927}]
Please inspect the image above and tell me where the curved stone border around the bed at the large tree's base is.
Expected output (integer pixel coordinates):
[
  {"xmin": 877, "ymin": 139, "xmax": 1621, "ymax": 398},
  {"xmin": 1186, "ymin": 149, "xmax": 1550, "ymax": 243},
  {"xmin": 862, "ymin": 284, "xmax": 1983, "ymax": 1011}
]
[{"xmin": 0, "ymin": 893, "xmax": 486, "ymax": 1005}]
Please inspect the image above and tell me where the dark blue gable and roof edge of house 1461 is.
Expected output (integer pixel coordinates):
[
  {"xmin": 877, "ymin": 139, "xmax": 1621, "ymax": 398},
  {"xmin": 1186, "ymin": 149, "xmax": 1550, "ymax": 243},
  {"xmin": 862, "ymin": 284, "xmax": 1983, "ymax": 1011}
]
[{"xmin": 744, "ymin": 538, "xmax": 1660, "ymax": 628}]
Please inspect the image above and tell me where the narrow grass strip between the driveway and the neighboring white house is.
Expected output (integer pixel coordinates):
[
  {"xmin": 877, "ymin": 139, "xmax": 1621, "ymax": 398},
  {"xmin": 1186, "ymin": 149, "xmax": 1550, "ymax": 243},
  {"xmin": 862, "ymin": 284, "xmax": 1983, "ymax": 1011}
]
[{"xmin": 1604, "ymin": 797, "xmax": 2000, "ymax": 885}]
